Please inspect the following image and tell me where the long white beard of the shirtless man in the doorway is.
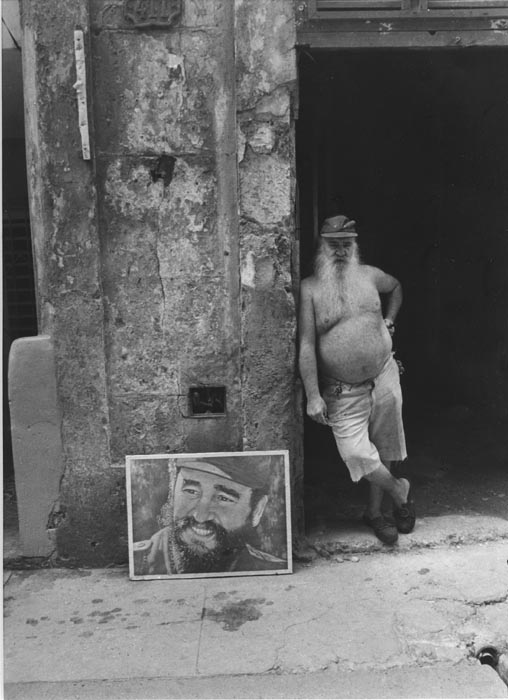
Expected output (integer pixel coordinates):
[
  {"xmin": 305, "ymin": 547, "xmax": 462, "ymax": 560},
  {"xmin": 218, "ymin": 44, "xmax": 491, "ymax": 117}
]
[{"xmin": 314, "ymin": 242, "xmax": 361, "ymax": 318}]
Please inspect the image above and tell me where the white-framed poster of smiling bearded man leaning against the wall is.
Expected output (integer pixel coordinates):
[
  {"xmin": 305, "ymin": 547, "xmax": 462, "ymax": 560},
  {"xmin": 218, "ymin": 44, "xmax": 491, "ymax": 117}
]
[{"xmin": 126, "ymin": 450, "xmax": 293, "ymax": 580}]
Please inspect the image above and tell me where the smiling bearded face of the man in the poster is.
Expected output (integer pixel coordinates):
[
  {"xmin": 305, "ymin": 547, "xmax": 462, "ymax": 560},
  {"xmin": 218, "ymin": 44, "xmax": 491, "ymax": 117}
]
[{"xmin": 174, "ymin": 467, "xmax": 267, "ymax": 572}]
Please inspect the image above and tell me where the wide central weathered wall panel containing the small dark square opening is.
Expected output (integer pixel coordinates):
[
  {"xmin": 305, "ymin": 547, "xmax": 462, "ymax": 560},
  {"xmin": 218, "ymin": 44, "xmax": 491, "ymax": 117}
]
[{"xmin": 92, "ymin": 2, "xmax": 242, "ymax": 464}]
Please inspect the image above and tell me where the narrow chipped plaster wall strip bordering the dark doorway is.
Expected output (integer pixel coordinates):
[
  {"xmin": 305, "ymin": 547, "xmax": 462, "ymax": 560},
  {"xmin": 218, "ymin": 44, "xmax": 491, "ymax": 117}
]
[{"xmin": 235, "ymin": 0, "xmax": 303, "ymax": 524}]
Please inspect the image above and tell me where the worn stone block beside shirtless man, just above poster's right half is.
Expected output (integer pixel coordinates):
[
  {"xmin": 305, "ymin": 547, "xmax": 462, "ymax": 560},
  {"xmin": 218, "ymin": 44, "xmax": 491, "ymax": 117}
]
[{"xmin": 241, "ymin": 222, "xmax": 296, "ymax": 449}]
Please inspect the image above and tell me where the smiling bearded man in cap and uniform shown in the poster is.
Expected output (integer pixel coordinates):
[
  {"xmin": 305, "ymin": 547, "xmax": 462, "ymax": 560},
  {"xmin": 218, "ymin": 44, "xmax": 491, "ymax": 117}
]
[{"xmin": 132, "ymin": 453, "xmax": 288, "ymax": 577}]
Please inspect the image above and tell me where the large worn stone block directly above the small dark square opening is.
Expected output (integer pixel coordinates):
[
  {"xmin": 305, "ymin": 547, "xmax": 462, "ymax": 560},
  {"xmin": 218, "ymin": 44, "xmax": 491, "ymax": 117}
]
[{"xmin": 99, "ymin": 152, "xmax": 240, "ymax": 404}]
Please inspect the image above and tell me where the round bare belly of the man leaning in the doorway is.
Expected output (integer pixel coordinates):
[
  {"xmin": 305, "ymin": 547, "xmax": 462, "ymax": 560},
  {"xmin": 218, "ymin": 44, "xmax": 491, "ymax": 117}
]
[{"xmin": 318, "ymin": 313, "xmax": 392, "ymax": 384}]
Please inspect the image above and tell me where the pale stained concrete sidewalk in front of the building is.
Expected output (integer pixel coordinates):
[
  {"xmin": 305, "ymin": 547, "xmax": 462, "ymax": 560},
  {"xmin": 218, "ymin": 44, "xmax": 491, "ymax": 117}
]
[{"xmin": 4, "ymin": 539, "xmax": 508, "ymax": 700}]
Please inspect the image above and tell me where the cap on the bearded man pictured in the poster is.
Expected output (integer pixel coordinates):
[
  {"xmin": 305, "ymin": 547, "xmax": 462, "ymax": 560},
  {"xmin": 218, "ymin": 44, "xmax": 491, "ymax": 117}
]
[{"xmin": 176, "ymin": 455, "xmax": 271, "ymax": 491}]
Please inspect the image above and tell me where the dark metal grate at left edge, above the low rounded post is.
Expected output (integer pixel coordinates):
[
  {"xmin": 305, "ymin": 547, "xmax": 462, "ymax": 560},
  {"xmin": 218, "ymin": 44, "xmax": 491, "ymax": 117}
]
[{"xmin": 3, "ymin": 209, "xmax": 37, "ymax": 341}]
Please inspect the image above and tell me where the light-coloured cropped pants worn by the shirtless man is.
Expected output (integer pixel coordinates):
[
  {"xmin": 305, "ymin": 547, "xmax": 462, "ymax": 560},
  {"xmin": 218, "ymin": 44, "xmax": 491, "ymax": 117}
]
[{"xmin": 323, "ymin": 355, "xmax": 407, "ymax": 481}]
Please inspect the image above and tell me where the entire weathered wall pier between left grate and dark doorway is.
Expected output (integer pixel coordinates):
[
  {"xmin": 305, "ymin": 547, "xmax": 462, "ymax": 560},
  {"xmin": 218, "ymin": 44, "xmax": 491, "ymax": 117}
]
[{"xmin": 22, "ymin": 0, "xmax": 302, "ymax": 565}]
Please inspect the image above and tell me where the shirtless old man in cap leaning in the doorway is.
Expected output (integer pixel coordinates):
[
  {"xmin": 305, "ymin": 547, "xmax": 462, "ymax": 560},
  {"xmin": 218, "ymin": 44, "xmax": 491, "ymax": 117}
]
[{"xmin": 299, "ymin": 215, "xmax": 415, "ymax": 544}]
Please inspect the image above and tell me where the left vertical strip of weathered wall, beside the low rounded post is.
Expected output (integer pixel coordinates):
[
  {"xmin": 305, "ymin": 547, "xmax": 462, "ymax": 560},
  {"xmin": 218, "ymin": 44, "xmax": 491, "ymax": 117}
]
[{"xmin": 22, "ymin": 0, "xmax": 125, "ymax": 561}]
